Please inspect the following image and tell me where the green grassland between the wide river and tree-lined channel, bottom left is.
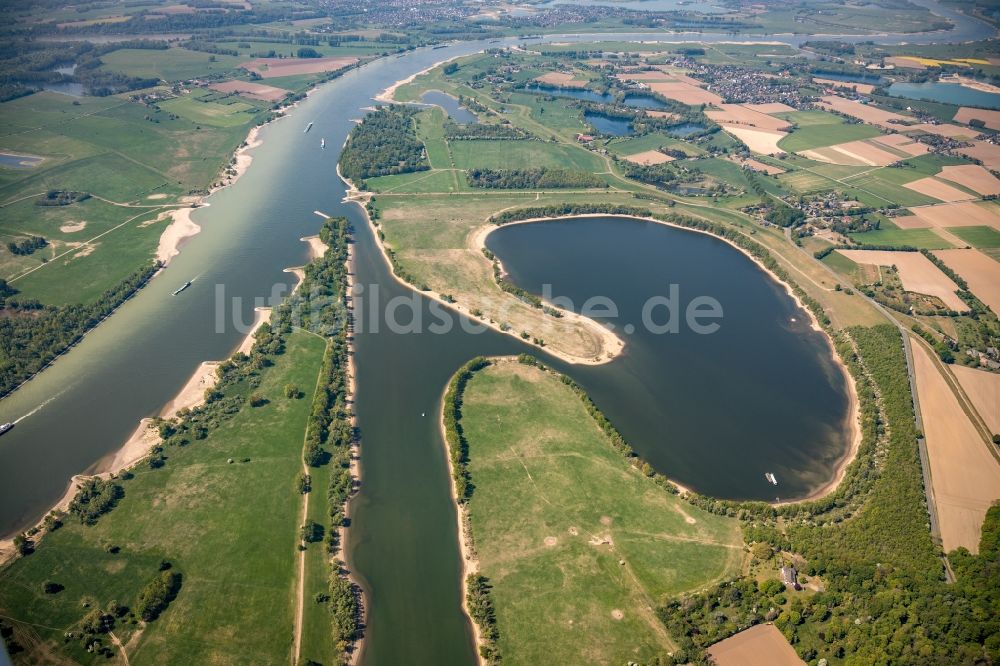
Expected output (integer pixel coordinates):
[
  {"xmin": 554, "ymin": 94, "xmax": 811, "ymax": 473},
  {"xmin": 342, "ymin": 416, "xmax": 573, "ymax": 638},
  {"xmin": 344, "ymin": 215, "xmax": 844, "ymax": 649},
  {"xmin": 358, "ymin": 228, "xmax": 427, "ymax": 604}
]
[{"xmin": 0, "ymin": 333, "xmax": 329, "ymax": 664}]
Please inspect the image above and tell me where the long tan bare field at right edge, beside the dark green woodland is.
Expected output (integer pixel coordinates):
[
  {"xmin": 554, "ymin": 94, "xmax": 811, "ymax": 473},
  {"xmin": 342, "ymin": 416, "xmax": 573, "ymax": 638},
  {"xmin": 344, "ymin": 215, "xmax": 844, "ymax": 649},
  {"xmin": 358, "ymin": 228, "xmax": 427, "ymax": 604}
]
[{"xmin": 913, "ymin": 340, "xmax": 1000, "ymax": 553}]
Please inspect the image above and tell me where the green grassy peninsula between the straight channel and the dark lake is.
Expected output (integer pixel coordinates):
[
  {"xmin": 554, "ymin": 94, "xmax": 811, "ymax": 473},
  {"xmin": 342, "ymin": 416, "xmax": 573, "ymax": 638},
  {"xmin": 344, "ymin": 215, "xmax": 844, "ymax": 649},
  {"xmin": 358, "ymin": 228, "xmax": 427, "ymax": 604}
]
[{"xmin": 462, "ymin": 363, "xmax": 742, "ymax": 664}]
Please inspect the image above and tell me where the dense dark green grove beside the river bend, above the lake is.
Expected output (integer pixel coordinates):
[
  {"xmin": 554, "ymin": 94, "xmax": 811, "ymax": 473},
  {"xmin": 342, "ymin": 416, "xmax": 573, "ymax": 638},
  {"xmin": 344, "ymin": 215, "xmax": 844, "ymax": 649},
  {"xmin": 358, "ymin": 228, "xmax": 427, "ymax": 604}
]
[{"xmin": 340, "ymin": 105, "xmax": 430, "ymax": 180}]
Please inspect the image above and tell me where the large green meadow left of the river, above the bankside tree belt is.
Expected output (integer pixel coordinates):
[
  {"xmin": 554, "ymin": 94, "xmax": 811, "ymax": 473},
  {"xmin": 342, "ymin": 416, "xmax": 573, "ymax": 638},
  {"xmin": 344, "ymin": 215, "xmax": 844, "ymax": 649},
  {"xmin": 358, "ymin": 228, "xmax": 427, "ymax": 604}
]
[{"xmin": 0, "ymin": 88, "xmax": 262, "ymax": 304}]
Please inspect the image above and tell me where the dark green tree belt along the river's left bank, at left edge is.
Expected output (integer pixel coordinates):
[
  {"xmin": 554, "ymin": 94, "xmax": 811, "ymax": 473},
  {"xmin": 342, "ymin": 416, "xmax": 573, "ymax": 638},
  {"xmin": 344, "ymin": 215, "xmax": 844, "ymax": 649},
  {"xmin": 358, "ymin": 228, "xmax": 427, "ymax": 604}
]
[{"xmin": 0, "ymin": 263, "xmax": 160, "ymax": 397}]
